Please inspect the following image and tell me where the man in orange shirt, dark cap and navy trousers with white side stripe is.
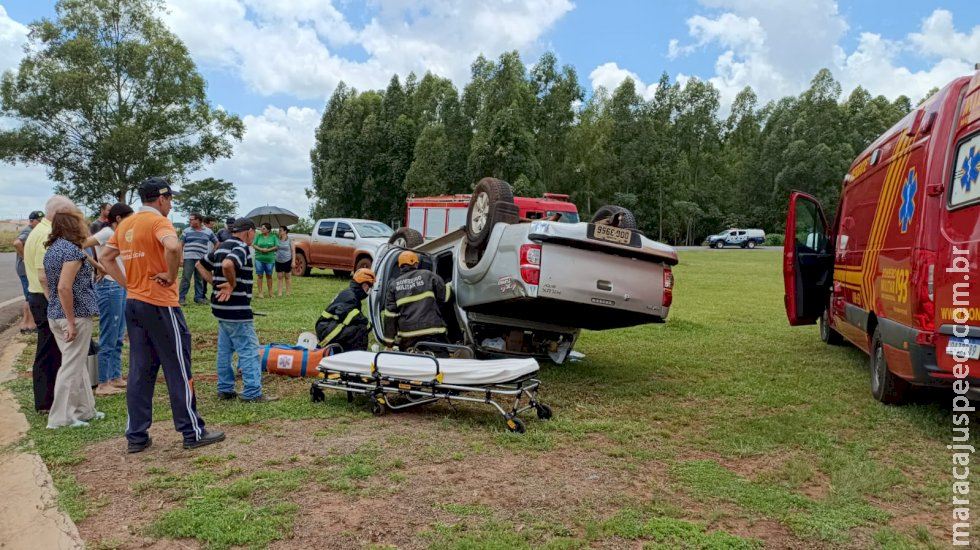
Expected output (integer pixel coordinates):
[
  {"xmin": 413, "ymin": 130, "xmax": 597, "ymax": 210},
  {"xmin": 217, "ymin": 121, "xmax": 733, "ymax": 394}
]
[{"xmin": 99, "ymin": 177, "xmax": 225, "ymax": 453}]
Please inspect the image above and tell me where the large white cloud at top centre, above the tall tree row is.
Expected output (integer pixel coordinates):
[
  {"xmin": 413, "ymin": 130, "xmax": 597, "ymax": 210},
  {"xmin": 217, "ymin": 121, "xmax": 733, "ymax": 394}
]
[{"xmin": 165, "ymin": 0, "xmax": 573, "ymax": 99}]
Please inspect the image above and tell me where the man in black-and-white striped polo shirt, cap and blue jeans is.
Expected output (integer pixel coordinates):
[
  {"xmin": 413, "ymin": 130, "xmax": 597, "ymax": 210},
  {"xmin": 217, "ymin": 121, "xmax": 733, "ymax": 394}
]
[{"xmin": 197, "ymin": 218, "xmax": 278, "ymax": 403}]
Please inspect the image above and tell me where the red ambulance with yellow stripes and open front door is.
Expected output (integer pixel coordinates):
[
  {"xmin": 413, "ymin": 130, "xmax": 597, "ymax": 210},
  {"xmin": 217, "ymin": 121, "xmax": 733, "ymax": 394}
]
[{"xmin": 783, "ymin": 65, "xmax": 980, "ymax": 403}]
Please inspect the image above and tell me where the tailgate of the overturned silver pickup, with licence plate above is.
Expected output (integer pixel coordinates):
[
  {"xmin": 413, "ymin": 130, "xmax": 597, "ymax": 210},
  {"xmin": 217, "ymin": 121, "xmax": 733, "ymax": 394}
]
[{"xmin": 538, "ymin": 242, "xmax": 667, "ymax": 328}]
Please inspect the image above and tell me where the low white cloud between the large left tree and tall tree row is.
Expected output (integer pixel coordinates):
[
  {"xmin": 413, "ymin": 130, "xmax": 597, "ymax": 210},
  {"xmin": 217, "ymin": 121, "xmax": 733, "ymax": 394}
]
[{"xmin": 190, "ymin": 106, "xmax": 320, "ymax": 217}]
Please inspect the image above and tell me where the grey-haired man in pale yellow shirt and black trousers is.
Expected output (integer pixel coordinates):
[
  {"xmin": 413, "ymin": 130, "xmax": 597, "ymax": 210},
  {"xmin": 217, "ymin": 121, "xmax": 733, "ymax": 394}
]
[{"xmin": 24, "ymin": 195, "xmax": 76, "ymax": 413}]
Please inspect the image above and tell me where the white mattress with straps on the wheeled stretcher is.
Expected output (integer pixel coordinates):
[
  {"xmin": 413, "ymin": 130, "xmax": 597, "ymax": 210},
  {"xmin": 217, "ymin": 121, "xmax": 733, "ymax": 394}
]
[{"xmin": 320, "ymin": 351, "xmax": 538, "ymax": 386}]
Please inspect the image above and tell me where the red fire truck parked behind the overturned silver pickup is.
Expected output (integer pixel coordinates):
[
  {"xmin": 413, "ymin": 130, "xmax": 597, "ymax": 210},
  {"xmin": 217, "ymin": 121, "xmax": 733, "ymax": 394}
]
[{"xmin": 405, "ymin": 193, "xmax": 579, "ymax": 240}]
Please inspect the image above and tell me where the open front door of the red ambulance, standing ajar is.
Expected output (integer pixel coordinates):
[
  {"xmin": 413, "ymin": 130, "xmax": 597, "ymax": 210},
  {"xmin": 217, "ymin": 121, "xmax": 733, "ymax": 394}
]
[{"xmin": 783, "ymin": 191, "xmax": 834, "ymax": 326}]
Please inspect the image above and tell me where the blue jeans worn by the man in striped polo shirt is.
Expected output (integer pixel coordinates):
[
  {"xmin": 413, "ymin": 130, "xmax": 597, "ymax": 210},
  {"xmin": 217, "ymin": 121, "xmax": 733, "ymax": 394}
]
[{"xmin": 218, "ymin": 320, "xmax": 262, "ymax": 399}]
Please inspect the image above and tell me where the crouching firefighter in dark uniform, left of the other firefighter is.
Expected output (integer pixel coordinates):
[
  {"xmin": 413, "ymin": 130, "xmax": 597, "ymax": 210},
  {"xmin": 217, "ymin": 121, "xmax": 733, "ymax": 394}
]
[{"xmin": 316, "ymin": 268, "xmax": 374, "ymax": 351}]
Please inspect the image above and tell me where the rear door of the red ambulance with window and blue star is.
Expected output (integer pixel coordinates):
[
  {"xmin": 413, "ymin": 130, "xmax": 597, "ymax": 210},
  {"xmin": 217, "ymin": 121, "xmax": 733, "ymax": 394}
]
[{"xmin": 931, "ymin": 125, "xmax": 980, "ymax": 374}]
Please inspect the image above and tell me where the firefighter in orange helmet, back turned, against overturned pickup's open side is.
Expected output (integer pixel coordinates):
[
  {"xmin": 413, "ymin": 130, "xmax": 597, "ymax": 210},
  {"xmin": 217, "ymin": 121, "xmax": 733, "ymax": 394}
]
[{"xmin": 384, "ymin": 250, "xmax": 452, "ymax": 350}]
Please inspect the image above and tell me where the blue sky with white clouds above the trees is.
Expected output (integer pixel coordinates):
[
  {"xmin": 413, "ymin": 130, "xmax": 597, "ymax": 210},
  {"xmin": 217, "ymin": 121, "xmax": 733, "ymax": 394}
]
[{"xmin": 0, "ymin": 0, "xmax": 980, "ymax": 221}]
